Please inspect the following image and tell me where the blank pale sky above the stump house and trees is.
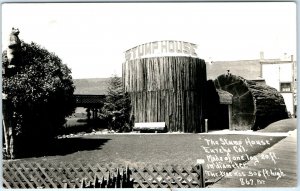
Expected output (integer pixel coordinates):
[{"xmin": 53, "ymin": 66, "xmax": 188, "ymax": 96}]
[{"xmin": 1, "ymin": 2, "xmax": 296, "ymax": 79}]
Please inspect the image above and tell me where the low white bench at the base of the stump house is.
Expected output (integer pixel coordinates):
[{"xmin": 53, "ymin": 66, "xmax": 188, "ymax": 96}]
[{"xmin": 133, "ymin": 122, "xmax": 166, "ymax": 132}]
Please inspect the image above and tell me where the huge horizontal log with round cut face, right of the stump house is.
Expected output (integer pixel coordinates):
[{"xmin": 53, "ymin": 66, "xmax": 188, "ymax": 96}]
[{"xmin": 214, "ymin": 74, "xmax": 288, "ymax": 130}]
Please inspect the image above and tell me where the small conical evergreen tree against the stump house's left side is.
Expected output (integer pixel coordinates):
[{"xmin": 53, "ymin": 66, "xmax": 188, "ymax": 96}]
[{"xmin": 100, "ymin": 75, "xmax": 131, "ymax": 132}]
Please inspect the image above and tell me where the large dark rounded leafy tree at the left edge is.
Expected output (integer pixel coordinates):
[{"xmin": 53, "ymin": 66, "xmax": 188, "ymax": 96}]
[{"xmin": 2, "ymin": 42, "xmax": 75, "ymax": 158}]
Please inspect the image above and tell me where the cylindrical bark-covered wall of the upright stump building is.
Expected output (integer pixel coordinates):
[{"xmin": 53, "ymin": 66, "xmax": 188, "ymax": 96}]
[{"xmin": 123, "ymin": 56, "xmax": 206, "ymax": 132}]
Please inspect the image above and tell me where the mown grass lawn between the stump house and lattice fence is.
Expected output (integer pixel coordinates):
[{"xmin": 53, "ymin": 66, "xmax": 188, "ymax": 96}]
[{"xmin": 10, "ymin": 134, "xmax": 283, "ymax": 179}]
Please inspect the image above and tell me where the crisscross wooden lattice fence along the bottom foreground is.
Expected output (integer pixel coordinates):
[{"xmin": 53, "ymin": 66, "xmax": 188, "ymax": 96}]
[{"xmin": 3, "ymin": 162, "xmax": 205, "ymax": 188}]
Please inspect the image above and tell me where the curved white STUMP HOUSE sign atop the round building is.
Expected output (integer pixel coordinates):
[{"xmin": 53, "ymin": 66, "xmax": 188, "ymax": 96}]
[{"xmin": 125, "ymin": 40, "xmax": 197, "ymax": 61}]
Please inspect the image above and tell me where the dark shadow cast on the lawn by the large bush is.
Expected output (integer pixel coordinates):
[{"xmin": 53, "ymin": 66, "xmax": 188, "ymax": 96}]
[{"xmin": 18, "ymin": 137, "xmax": 111, "ymax": 158}]
